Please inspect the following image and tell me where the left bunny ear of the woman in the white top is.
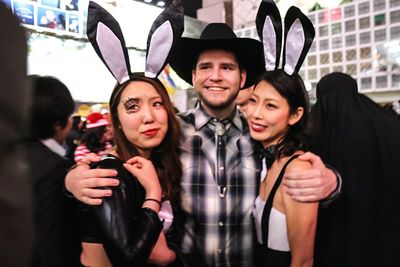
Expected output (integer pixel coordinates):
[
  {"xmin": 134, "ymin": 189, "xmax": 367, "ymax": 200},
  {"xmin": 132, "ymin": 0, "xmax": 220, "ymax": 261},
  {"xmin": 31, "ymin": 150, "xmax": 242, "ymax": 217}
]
[{"xmin": 256, "ymin": 0, "xmax": 282, "ymax": 71}]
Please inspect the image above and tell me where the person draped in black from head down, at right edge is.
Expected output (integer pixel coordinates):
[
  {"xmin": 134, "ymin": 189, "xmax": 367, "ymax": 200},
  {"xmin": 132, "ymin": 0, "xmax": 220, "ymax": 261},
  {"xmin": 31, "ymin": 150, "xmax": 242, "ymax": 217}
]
[{"xmin": 311, "ymin": 73, "xmax": 400, "ymax": 266}]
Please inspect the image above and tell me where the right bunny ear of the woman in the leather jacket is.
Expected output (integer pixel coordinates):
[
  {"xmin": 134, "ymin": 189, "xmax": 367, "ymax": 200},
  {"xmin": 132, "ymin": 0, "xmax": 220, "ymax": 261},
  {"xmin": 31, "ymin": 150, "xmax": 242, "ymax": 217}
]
[{"xmin": 145, "ymin": 0, "xmax": 184, "ymax": 78}]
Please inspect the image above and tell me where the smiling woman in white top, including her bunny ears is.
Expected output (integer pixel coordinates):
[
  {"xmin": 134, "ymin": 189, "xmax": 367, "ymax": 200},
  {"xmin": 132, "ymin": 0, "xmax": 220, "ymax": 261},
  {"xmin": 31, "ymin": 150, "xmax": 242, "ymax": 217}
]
[{"xmin": 247, "ymin": 1, "xmax": 318, "ymax": 266}]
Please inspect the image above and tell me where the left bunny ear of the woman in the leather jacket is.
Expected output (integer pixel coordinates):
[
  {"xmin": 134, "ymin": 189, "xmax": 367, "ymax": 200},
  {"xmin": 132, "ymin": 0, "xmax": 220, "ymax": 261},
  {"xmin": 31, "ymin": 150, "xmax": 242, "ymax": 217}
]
[{"xmin": 87, "ymin": 1, "xmax": 131, "ymax": 84}]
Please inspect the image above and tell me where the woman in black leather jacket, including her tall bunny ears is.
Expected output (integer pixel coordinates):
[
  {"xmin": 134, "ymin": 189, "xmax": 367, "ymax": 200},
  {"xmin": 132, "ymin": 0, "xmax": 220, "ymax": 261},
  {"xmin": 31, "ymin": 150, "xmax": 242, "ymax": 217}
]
[{"xmin": 81, "ymin": 1, "xmax": 188, "ymax": 266}]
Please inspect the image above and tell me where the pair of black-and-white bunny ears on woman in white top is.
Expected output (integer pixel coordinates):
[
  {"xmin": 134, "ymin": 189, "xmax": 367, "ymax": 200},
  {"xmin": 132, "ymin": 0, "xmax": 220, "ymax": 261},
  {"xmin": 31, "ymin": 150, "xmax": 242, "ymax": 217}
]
[{"xmin": 256, "ymin": 0, "xmax": 315, "ymax": 75}]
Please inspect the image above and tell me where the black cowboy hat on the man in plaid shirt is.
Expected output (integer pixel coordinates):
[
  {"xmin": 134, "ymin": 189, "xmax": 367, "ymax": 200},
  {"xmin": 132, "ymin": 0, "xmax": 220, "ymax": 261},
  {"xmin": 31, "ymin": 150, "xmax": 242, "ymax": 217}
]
[{"xmin": 169, "ymin": 23, "xmax": 265, "ymax": 88}]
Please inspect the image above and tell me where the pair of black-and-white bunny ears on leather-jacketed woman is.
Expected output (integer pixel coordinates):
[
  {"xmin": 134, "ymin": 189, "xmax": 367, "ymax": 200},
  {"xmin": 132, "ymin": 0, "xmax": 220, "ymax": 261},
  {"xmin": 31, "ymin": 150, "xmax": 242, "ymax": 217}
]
[{"xmin": 87, "ymin": 0, "xmax": 183, "ymax": 84}]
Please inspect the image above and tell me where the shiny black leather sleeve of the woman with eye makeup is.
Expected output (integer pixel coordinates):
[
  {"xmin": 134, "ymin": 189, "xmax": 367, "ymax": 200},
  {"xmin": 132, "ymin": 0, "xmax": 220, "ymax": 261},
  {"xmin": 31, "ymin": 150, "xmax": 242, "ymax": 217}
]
[{"xmin": 93, "ymin": 157, "xmax": 162, "ymax": 267}]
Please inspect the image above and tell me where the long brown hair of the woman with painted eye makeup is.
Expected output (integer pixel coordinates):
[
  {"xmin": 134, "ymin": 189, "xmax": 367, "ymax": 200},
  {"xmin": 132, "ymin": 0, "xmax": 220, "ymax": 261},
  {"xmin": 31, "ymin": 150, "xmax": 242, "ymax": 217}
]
[{"xmin": 110, "ymin": 73, "xmax": 182, "ymax": 205}]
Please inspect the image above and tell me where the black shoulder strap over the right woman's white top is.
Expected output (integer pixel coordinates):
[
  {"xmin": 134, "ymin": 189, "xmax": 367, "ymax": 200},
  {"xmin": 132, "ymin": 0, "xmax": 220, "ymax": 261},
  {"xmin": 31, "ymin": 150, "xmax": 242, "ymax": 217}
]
[{"xmin": 261, "ymin": 155, "xmax": 299, "ymax": 246}]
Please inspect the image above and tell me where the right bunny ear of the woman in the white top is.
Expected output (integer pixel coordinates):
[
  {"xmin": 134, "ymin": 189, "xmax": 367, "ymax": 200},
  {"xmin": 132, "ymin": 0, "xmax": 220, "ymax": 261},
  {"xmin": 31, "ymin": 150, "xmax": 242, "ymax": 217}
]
[{"xmin": 282, "ymin": 6, "xmax": 315, "ymax": 75}]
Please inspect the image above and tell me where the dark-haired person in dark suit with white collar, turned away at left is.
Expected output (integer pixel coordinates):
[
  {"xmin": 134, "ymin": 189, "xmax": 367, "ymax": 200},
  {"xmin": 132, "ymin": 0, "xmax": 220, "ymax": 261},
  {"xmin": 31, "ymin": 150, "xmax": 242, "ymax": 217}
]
[{"xmin": 24, "ymin": 76, "xmax": 80, "ymax": 267}]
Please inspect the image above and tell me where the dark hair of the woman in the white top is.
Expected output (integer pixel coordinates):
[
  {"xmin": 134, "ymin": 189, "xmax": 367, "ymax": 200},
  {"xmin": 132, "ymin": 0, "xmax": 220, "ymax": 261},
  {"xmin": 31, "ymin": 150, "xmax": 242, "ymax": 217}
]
[{"xmin": 258, "ymin": 69, "xmax": 310, "ymax": 158}]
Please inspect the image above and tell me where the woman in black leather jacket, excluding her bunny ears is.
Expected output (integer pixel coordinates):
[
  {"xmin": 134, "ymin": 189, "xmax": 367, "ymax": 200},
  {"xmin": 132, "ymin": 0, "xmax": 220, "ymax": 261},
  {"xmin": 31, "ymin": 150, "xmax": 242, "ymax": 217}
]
[{"xmin": 81, "ymin": 76, "xmax": 181, "ymax": 266}]
